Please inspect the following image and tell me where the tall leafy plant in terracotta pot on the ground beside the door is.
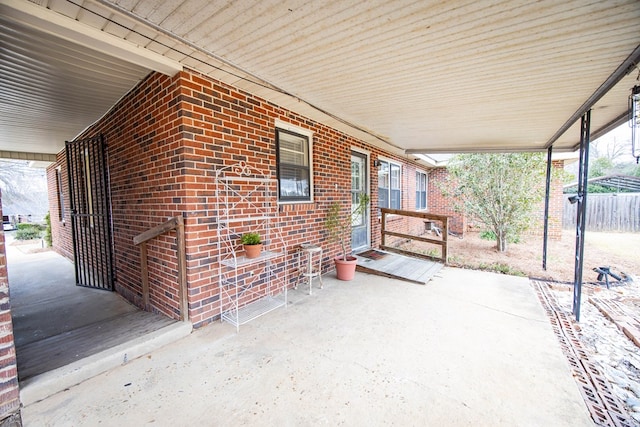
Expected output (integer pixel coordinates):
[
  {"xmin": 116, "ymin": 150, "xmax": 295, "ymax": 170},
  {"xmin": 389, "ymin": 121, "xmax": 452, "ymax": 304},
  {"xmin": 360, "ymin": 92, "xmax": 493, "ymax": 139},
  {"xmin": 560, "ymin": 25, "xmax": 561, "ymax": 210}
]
[{"xmin": 325, "ymin": 194, "xmax": 369, "ymax": 280}]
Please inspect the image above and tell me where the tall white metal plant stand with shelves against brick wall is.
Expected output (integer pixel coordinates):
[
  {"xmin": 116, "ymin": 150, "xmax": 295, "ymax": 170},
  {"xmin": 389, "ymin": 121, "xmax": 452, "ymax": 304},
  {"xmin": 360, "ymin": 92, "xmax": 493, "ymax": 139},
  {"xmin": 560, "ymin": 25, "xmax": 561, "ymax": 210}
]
[{"xmin": 215, "ymin": 162, "xmax": 289, "ymax": 331}]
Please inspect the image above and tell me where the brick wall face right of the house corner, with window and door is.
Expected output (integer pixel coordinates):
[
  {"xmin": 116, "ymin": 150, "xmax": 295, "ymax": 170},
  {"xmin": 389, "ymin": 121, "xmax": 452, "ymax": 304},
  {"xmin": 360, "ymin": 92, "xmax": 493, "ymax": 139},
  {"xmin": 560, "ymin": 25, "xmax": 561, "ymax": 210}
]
[{"xmin": 182, "ymin": 73, "xmax": 432, "ymax": 325}]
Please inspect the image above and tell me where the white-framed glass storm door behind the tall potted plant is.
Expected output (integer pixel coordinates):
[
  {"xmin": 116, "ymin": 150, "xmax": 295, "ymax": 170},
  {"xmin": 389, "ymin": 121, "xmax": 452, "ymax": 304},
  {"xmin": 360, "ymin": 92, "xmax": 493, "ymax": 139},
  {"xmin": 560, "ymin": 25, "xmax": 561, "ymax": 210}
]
[{"xmin": 351, "ymin": 151, "xmax": 371, "ymax": 252}]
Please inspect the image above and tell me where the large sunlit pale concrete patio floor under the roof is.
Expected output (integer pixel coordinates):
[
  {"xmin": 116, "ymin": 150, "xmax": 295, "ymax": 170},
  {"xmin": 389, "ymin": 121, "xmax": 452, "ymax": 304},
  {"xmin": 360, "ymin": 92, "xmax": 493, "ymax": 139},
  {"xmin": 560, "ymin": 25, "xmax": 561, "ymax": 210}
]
[{"xmin": 23, "ymin": 268, "xmax": 593, "ymax": 426}]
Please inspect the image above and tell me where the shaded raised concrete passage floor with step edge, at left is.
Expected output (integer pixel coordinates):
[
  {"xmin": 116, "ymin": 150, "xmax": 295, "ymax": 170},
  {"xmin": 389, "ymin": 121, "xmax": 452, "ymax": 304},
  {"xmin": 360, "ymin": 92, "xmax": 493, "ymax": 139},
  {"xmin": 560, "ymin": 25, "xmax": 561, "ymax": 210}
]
[{"xmin": 7, "ymin": 238, "xmax": 192, "ymax": 405}]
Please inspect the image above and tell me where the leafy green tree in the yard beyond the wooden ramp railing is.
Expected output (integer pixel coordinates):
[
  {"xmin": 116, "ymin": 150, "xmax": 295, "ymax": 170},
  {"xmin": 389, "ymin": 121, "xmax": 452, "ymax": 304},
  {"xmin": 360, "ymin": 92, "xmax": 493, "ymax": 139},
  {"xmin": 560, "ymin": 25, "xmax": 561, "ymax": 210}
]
[{"xmin": 448, "ymin": 153, "xmax": 546, "ymax": 252}]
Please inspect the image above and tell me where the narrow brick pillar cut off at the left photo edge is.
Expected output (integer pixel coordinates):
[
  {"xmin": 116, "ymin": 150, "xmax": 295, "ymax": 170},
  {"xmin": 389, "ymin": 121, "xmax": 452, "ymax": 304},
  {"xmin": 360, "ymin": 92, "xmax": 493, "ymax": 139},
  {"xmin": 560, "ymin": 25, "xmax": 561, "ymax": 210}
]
[{"xmin": 0, "ymin": 194, "xmax": 21, "ymax": 425}]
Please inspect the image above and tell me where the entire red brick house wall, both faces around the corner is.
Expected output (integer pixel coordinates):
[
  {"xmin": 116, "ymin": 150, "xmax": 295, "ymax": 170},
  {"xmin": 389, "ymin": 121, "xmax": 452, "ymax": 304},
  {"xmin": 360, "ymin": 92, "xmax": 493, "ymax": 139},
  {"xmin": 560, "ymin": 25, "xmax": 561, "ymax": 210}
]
[{"xmin": 49, "ymin": 71, "xmax": 436, "ymax": 326}]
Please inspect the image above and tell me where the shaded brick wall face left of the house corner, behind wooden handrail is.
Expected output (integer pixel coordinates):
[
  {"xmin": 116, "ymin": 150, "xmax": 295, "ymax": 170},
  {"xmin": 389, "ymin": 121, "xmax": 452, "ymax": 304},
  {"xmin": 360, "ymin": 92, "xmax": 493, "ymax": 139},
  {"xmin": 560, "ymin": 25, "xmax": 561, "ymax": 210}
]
[{"xmin": 47, "ymin": 74, "xmax": 186, "ymax": 318}]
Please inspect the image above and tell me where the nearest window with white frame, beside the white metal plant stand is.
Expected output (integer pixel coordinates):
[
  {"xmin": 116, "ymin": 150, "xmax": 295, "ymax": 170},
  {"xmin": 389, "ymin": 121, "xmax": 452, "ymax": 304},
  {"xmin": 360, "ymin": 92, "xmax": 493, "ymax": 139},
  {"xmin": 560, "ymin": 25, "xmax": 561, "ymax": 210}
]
[{"xmin": 276, "ymin": 129, "xmax": 313, "ymax": 202}]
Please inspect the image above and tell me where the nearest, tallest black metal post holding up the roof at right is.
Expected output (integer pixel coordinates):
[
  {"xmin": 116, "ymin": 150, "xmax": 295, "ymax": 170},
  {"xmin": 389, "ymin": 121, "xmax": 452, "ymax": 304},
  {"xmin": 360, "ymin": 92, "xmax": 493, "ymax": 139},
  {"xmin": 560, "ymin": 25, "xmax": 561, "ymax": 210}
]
[{"xmin": 573, "ymin": 110, "xmax": 591, "ymax": 322}]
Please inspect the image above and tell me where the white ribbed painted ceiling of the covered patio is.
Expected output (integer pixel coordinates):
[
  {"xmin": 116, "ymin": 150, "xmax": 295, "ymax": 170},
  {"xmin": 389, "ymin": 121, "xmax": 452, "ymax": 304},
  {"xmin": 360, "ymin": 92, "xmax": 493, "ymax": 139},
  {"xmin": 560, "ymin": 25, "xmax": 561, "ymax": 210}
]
[{"xmin": 0, "ymin": 0, "xmax": 640, "ymax": 159}]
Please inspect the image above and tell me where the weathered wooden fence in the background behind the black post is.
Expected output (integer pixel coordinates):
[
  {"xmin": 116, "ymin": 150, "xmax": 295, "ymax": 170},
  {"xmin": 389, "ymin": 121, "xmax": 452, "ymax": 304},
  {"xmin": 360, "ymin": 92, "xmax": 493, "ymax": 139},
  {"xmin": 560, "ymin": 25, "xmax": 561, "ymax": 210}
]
[{"xmin": 562, "ymin": 193, "xmax": 640, "ymax": 233}]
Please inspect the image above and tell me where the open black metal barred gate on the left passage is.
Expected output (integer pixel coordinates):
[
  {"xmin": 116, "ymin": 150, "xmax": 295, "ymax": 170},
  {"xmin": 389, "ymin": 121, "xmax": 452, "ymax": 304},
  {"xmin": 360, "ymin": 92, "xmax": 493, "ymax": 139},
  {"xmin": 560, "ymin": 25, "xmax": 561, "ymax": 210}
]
[{"xmin": 66, "ymin": 135, "xmax": 113, "ymax": 291}]
